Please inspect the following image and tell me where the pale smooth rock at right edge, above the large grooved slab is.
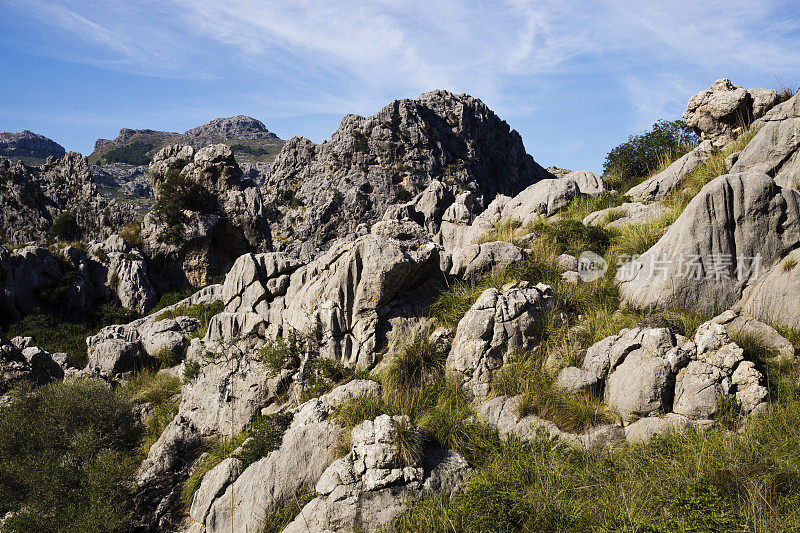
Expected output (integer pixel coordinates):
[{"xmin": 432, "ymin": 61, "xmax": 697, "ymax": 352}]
[{"xmin": 731, "ymin": 91, "xmax": 800, "ymax": 188}]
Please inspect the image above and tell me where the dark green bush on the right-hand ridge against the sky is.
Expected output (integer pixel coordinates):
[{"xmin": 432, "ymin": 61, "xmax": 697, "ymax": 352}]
[{"xmin": 603, "ymin": 120, "xmax": 697, "ymax": 188}]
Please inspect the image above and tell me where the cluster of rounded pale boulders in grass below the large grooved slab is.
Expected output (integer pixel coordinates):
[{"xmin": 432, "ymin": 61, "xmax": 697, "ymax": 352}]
[{"xmin": 556, "ymin": 316, "xmax": 768, "ymax": 424}]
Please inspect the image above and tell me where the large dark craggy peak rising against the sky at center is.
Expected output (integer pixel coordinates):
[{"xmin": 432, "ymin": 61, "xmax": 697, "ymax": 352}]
[{"xmin": 264, "ymin": 91, "xmax": 550, "ymax": 259}]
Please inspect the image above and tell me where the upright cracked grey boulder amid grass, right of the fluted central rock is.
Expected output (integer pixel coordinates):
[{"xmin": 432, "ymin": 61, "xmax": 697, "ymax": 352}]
[{"xmin": 446, "ymin": 283, "xmax": 553, "ymax": 397}]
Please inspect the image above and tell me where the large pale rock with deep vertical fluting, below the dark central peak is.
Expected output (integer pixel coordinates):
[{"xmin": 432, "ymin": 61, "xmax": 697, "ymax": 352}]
[{"xmin": 282, "ymin": 234, "xmax": 441, "ymax": 368}]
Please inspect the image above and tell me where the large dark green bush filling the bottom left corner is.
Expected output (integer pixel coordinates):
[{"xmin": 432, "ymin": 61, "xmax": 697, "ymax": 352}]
[{"xmin": 0, "ymin": 380, "xmax": 141, "ymax": 532}]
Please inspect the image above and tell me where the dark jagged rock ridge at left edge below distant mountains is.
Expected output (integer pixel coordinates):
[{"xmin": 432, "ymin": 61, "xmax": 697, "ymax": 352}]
[{"xmin": 0, "ymin": 152, "xmax": 136, "ymax": 244}]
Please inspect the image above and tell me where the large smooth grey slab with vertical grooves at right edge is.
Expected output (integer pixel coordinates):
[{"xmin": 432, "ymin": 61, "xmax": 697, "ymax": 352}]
[{"xmin": 617, "ymin": 173, "xmax": 800, "ymax": 313}]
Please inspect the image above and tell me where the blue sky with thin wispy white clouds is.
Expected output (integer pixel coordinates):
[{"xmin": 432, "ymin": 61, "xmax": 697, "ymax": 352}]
[{"xmin": 0, "ymin": 0, "xmax": 800, "ymax": 171}]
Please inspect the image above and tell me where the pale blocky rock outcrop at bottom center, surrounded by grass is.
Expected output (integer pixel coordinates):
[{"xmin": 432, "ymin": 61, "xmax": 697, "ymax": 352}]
[{"xmin": 284, "ymin": 415, "xmax": 470, "ymax": 533}]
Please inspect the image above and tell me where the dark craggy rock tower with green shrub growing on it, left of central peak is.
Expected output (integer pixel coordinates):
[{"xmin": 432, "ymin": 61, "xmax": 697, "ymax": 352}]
[{"xmin": 142, "ymin": 144, "xmax": 271, "ymax": 292}]
